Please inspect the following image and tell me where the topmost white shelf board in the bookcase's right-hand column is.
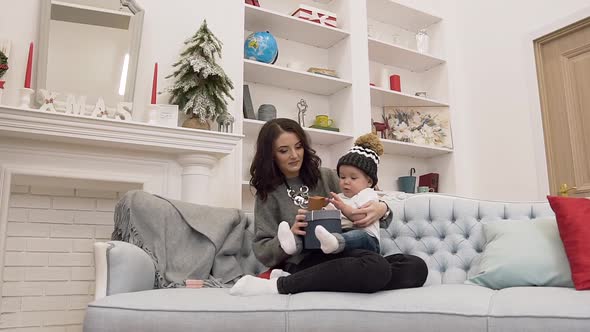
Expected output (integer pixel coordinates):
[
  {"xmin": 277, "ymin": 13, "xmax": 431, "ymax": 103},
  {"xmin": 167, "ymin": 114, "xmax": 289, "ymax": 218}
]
[{"xmin": 367, "ymin": 0, "xmax": 441, "ymax": 32}]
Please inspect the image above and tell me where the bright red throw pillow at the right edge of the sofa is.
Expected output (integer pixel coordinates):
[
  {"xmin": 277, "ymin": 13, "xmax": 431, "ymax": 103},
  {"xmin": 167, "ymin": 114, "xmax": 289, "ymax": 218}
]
[{"xmin": 547, "ymin": 196, "xmax": 590, "ymax": 290}]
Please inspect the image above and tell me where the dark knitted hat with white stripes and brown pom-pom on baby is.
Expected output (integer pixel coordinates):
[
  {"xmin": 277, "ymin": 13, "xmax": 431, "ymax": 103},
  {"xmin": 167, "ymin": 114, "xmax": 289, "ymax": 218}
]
[{"xmin": 336, "ymin": 133, "xmax": 383, "ymax": 188}]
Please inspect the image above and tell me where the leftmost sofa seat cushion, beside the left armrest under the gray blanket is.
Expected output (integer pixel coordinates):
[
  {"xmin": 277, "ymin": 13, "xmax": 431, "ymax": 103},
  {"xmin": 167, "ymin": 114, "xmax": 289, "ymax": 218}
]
[{"xmin": 84, "ymin": 288, "xmax": 289, "ymax": 332}]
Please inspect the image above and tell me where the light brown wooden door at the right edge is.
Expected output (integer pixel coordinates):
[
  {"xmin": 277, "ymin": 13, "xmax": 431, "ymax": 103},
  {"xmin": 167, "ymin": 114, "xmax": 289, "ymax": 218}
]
[{"xmin": 534, "ymin": 17, "xmax": 590, "ymax": 197}]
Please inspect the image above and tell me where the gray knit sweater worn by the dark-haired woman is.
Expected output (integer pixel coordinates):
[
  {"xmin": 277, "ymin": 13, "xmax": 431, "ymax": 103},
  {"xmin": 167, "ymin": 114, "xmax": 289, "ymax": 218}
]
[{"xmin": 252, "ymin": 167, "xmax": 340, "ymax": 267}]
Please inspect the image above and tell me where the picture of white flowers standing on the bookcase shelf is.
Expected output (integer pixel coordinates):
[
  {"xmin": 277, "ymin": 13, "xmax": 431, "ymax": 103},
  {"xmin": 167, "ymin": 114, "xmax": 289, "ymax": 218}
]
[{"xmin": 383, "ymin": 107, "xmax": 453, "ymax": 149}]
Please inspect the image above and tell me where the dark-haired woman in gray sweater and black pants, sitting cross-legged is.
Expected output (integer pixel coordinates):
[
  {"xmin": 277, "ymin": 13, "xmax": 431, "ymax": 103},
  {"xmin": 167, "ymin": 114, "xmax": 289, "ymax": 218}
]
[{"xmin": 230, "ymin": 118, "xmax": 428, "ymax": 295}]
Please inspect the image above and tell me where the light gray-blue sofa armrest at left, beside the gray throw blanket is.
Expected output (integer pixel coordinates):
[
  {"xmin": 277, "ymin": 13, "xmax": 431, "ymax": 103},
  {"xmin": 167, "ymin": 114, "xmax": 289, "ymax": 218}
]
[{"xmin": 94, "ymin": 241, "xmax": 156, "ymax": 300}]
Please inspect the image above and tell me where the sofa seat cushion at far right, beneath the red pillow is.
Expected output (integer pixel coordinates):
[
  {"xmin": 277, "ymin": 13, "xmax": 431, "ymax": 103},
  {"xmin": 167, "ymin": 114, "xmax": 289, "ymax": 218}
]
[{"xmin": 488, "ymin": 287, "xmax": 590, "ymax": 332}]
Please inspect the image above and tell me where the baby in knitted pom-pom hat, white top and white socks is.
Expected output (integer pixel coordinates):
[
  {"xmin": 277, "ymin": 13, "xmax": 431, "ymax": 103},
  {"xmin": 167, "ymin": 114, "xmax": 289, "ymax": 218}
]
[{"xmin": 278, "ymin": 134, "xmax": 383, "ymax": 255}]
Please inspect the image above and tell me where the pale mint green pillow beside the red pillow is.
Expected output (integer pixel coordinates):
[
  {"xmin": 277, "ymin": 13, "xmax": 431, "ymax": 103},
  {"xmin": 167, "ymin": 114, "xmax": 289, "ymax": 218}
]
[{"xmin": 466, "ymin": 218, "xmax": 574, "ymax": 289}]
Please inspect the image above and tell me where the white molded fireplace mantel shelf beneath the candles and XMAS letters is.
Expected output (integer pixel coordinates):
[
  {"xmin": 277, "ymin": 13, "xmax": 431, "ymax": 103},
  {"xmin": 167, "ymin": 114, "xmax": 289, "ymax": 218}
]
[{"xmin": 0, "ymin": 106, "xmax": 243, "ymax": 158}]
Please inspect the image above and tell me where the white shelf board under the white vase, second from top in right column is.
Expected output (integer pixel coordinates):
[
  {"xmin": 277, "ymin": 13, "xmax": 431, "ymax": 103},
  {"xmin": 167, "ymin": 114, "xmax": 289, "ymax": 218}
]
[{"xmin": 369, "ymin": 38, "xmax": 445, "ymax": 72}]
